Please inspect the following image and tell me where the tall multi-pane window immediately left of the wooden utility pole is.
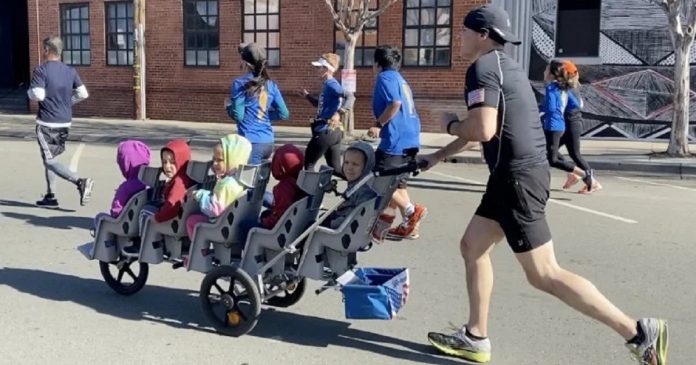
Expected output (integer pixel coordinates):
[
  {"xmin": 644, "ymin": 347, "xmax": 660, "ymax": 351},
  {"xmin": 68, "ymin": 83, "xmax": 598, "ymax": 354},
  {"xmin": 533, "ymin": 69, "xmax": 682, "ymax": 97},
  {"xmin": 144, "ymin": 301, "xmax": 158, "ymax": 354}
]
[{"xmin": 106, "ymin": 2, "xmax": 135, "ymax": 66}]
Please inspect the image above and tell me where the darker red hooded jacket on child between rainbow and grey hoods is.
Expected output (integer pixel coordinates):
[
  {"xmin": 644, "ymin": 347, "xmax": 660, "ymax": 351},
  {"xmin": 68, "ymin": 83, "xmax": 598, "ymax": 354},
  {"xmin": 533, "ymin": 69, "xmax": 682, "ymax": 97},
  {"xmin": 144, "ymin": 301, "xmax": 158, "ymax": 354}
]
[{"xmin": 261, "ymin": 144, "xmax": 305, "ymax": 229}]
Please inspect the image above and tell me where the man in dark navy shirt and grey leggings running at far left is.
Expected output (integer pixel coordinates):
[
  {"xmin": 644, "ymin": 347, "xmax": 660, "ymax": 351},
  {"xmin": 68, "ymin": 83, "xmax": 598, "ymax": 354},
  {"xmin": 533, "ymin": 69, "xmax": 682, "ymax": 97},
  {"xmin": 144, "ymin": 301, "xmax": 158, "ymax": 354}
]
[{"xmin": 27, "ymin": 37, "xmax": 94, "ymax": 207}]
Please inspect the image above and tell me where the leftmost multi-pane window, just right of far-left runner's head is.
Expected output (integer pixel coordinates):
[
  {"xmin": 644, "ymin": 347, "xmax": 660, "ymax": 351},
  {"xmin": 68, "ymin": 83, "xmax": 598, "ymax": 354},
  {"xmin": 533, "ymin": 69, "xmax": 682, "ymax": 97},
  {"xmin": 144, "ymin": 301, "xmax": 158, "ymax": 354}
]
[{"xmin": 60, "ymin": 4, "xmax": 92, "ymax": 66}]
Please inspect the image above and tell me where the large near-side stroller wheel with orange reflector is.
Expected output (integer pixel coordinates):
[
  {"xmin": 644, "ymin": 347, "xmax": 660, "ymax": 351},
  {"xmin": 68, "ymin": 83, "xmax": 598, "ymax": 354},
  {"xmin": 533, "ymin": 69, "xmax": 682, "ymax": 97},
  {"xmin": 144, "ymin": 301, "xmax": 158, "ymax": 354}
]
[{"xmin": 200, "ymin": 266, "xmax": 261, "ymax": 337}]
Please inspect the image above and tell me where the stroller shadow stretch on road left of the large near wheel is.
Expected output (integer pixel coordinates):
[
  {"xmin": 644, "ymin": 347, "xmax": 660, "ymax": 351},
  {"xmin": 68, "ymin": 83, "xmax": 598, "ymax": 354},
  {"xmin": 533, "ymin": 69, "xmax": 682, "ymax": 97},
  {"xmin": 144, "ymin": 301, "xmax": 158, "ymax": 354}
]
[{"xmin": 0, "ymin": 268, "xmax": 215, "ymax": 333}]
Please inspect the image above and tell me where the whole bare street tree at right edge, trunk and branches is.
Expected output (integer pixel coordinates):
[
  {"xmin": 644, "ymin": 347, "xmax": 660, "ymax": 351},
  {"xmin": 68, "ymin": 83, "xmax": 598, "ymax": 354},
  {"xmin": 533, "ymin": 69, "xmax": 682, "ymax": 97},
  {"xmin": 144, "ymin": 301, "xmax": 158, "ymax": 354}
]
[{"xmin": 649, "ymin": 0, "xmax": 696, "ymax": 156}]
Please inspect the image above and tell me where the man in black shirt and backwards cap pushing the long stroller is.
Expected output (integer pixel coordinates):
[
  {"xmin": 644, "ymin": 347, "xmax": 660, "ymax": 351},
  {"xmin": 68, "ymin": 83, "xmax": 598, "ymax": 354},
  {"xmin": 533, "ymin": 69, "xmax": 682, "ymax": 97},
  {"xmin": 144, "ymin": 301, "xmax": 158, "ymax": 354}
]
[{"xmin": 421, "ymin": 5, "xmax": 667, "ymax": 365}]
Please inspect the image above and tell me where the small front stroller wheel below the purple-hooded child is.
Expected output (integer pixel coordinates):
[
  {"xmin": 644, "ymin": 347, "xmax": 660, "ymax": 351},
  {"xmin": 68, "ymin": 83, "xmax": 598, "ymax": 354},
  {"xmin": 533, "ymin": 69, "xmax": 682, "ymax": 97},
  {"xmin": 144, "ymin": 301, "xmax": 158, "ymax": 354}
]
[{"xmin": 99, "ymin": 258, "xmax": 149, "ymax": 295}]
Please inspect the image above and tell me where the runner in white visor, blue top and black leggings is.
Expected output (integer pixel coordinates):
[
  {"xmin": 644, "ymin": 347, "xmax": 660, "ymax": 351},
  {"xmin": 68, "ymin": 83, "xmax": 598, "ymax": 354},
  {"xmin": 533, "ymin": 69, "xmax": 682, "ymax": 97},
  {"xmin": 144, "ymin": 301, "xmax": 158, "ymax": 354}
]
[{"xmin": 302, "ymin": 53, "xmax": 354, "ymax": 172}]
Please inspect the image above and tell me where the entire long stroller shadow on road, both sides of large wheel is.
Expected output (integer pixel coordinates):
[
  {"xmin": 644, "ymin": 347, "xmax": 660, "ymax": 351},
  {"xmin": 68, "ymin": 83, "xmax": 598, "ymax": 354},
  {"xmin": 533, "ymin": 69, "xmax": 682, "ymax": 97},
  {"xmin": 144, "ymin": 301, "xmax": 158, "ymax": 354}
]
[{"xmin": 0, "ymin": 265, "xmax": 474, "ymax": 365}]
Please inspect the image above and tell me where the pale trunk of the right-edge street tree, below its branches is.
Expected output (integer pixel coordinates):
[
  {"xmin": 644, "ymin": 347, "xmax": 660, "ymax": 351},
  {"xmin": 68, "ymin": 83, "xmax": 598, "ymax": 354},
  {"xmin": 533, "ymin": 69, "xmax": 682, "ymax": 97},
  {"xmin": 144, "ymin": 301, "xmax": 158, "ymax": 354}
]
[{"xmin": 667, "ymin": 39, "xmax": 691, "ymax": 157}]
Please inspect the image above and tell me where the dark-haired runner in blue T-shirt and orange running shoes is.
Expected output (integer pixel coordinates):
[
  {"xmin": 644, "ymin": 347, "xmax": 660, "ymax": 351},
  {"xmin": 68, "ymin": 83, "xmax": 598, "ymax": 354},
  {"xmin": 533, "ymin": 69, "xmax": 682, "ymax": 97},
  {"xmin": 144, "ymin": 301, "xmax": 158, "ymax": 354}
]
[{"xmin": 368, "ymin": 46, "xmax": 427, "ymax": 241}]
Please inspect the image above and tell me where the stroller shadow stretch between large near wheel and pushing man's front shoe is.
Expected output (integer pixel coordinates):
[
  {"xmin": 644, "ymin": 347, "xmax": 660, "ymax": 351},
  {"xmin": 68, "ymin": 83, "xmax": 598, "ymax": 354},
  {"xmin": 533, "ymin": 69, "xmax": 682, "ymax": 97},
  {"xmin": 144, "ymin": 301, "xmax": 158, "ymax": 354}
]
[{"xmin": 250, "ymin": 308, "xmax": 474, "ymax": 365}]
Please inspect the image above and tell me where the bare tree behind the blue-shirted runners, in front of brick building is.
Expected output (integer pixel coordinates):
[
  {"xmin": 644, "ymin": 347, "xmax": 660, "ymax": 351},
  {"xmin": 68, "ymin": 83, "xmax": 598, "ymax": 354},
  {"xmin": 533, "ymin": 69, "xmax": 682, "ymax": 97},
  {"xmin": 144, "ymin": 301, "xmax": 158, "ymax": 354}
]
[{"xmin": 324, "ymin": 0, "xmax": 397, "ymax": 135}]
